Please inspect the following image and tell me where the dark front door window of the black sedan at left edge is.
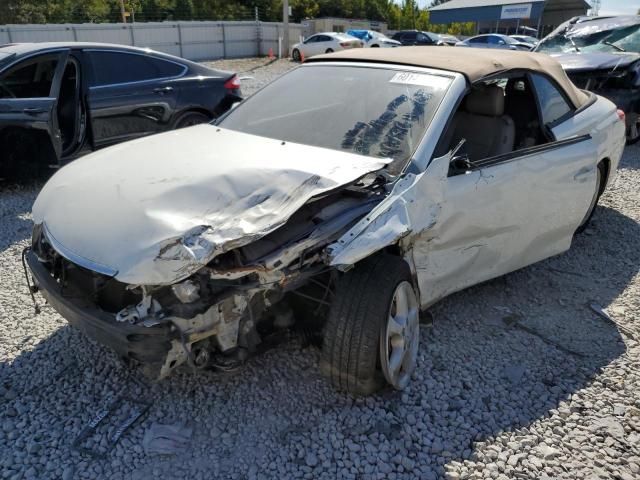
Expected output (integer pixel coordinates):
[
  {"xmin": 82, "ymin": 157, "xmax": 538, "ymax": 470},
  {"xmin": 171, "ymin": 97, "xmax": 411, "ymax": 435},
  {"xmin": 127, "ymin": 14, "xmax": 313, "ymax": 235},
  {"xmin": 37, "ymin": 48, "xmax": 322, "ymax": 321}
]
[{"xmin": 0, "ymin": 54, "xmax": 59, "ymax": 98}]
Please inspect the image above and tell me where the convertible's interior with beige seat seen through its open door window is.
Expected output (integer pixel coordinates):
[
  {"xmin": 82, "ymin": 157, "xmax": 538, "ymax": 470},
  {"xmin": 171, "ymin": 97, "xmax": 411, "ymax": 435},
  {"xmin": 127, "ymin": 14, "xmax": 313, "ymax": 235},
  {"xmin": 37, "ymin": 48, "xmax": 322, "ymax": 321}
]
[{"xmin": 436, "ymin": 71, "xmax": 549, "ymax": 167}]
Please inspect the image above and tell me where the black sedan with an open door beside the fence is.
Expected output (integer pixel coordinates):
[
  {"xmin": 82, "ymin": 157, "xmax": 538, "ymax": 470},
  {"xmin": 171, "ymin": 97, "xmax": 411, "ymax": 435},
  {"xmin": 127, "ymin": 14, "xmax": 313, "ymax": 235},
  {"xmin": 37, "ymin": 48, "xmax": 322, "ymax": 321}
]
[{"xmin": 0, "ymin": 42, "xmax": 241, "ymax": 178}]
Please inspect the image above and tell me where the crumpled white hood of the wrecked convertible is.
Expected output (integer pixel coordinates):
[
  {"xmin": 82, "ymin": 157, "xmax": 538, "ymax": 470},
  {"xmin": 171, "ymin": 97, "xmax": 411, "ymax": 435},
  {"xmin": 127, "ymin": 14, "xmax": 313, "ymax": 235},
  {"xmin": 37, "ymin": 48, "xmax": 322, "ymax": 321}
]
[{"xmin": 33, "ymin": 125, "xmax": 390, "ymax": 285}]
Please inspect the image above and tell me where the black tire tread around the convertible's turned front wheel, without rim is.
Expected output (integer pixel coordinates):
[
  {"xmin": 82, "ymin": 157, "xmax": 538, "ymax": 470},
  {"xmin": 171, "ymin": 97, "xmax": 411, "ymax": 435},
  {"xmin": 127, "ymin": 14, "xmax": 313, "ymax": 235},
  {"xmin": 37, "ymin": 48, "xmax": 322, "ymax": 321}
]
[{"xmin": 320, "ymin": 254, "xmax": 411, "ymax": 396}]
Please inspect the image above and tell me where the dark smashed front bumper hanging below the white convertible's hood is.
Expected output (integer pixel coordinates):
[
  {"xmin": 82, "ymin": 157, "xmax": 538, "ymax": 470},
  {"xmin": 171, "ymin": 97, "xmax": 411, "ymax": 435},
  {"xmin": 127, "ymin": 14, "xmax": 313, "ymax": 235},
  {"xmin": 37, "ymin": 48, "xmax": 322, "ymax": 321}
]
[{"xmin": 26, "ymin": 250, "xmax": 173, "ymax": 366}]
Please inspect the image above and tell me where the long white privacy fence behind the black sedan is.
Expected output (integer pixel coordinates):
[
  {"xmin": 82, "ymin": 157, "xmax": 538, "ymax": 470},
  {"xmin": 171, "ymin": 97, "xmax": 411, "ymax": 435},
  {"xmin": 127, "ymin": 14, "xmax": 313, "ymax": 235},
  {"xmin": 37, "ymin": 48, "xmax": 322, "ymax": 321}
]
[{"xmin": 0, "ymin": 22, "xmax": 302, "ymax": 60}]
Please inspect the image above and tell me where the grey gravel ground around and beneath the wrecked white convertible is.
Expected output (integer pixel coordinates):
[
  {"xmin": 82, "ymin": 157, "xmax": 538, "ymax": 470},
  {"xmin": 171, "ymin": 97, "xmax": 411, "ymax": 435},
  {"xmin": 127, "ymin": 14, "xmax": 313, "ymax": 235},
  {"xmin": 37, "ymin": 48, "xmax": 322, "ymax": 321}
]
[{"xmin": 0, "ymin": 60, "xmax": 640, "ymax": 480}]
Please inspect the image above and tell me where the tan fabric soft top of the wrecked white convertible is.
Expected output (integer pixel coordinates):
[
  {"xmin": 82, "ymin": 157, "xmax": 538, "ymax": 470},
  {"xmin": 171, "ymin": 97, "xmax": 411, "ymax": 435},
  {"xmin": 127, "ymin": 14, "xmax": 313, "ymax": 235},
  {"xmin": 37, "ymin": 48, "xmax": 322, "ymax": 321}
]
[{"xmin": 307, "ymin": 47, "xmax": 589, "ymax": 108}]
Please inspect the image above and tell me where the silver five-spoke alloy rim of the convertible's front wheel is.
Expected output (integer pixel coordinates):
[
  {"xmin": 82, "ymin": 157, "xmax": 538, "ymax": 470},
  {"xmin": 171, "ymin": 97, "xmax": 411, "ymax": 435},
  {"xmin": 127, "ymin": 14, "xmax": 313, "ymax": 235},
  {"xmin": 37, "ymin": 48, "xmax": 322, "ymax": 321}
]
[{"xmin": 380, "ymin": 281, "xmax": 420, "ymax": 390}]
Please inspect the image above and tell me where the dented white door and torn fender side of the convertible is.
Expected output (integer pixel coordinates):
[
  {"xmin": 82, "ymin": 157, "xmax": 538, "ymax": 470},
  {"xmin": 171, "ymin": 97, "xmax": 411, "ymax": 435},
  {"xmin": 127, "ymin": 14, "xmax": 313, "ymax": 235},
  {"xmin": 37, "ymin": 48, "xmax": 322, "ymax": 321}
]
[{"xmin": 327, "ymin": 127, "xmax": 597, "ymax": 307}]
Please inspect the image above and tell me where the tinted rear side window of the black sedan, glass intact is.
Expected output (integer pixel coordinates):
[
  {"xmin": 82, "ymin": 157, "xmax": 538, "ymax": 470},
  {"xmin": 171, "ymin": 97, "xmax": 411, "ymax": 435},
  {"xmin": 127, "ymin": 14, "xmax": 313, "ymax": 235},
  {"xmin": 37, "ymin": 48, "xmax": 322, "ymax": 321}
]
[{"xmin": 90, "ymin": 51, "xmax": 184, "ymax": 86}]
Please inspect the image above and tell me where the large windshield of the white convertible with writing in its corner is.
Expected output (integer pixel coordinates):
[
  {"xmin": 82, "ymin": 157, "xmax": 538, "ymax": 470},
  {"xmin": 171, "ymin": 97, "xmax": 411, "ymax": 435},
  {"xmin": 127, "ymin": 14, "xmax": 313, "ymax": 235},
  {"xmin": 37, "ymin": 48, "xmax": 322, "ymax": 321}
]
[{"xmin": 219, "ymin": 64, "xmax": 453, "ymax": 171}]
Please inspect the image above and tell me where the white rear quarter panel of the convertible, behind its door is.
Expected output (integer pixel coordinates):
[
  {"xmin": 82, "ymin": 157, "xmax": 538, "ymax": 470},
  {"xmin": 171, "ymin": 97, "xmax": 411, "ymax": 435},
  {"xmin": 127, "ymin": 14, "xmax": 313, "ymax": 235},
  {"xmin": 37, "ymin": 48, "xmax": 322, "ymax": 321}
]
[{"xmin": 553, "ymin": 94, "xmax": 625, "ymax": 186}]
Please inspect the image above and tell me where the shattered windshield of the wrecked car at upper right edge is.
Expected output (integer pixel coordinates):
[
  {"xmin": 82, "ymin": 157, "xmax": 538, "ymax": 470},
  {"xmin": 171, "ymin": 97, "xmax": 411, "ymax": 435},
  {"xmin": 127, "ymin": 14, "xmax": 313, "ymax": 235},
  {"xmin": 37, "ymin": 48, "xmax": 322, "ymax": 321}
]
[{"xmin": 536, "ymin": 24, "xmax": 640, "ymax": 53}]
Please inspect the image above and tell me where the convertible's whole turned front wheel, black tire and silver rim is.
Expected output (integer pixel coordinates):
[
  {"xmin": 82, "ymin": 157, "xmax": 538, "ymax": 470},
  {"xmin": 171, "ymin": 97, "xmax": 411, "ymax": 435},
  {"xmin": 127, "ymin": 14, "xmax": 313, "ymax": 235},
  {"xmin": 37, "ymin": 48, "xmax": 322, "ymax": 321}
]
[{"xmin": 320, "ymin": 254, "xmax": 420, "ymax": 395}]
